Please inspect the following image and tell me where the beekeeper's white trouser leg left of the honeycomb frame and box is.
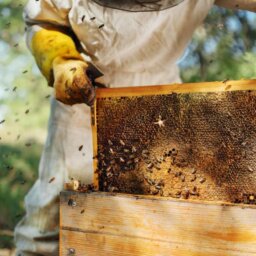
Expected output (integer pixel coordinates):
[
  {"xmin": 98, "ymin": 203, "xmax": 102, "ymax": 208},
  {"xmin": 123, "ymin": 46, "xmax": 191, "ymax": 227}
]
[{"xmin": 15, "ymin": 99, "xmax": 93, "ymax": 256}]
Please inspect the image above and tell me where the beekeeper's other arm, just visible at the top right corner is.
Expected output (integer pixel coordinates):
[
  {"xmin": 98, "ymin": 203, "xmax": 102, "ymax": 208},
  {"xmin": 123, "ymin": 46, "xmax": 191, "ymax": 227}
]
[{"xmin": 215, "ymin": 0, "xmax": 256, "ymax": 12}]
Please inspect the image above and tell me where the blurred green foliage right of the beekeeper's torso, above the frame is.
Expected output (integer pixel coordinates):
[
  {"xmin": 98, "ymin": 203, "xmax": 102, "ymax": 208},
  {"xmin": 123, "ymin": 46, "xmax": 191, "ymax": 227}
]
[{"xmin": 180, "ymin": 7, "xmax": 256, "ymax": 82}]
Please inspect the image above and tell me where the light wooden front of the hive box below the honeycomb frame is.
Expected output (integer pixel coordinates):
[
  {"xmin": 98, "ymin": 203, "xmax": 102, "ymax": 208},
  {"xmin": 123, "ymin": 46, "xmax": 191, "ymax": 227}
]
[{"xmin": 60, "ymin": 192, "xmax": 256, "ymax": 256}]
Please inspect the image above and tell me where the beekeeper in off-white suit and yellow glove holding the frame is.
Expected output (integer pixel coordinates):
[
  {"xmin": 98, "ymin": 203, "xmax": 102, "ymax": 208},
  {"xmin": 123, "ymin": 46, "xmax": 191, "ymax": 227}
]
[{"xmin": 15, "ymin": 0, "xmax": 256, "ymax": 256}]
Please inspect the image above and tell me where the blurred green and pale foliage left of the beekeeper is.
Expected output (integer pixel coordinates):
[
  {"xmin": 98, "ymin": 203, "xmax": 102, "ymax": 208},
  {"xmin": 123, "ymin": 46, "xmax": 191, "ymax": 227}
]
[{"xmin": 0, "ymin": 0, "xmax": 51, "ymax": 248}]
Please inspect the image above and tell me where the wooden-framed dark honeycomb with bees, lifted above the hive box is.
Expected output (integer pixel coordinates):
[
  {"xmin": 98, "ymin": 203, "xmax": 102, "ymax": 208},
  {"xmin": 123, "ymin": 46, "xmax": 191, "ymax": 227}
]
[{"xmin": 93, "ymin": 80, "xmax": 256, "ymax": 204}]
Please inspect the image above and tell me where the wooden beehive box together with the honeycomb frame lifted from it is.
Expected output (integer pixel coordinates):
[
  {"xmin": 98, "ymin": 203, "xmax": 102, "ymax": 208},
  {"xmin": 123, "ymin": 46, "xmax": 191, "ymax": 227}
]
[{"xmin": 60, "ymin": 80, "xmax": 256, "ymax": 256}]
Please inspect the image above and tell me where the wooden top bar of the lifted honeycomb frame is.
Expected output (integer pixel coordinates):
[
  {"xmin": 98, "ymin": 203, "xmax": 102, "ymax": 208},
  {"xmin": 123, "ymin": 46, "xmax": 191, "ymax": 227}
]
[{"xmin": 96, "ymin": 79, "xmax": 256, "ymax": 99}]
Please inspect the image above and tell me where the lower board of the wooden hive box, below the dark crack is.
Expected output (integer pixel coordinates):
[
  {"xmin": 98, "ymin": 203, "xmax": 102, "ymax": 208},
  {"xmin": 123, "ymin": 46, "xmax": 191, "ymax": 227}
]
[{"xmin": 61, "ymin": 230, "xmax": 254, "ymax": 256}]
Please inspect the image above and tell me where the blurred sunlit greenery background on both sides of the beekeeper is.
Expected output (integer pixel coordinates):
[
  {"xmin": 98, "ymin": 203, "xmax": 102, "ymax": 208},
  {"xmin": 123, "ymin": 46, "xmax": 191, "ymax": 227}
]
[{"xmin": 0, "ymin": 0, "xmax": 256, "ymax": 252}]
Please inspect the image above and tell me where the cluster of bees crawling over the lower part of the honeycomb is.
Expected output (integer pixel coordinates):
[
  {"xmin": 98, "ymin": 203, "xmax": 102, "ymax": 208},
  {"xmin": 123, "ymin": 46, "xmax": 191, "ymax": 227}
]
[{"xmin": 94, "ymin": 134, "xmax": 256, "ymax": 204}]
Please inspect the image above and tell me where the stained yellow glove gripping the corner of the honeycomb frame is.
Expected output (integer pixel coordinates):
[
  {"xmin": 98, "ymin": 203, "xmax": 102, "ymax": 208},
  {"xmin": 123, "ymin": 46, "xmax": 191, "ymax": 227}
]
[{"xmin": 31, "ymin": 29, "xmax": 95, "ymax": 105}]
